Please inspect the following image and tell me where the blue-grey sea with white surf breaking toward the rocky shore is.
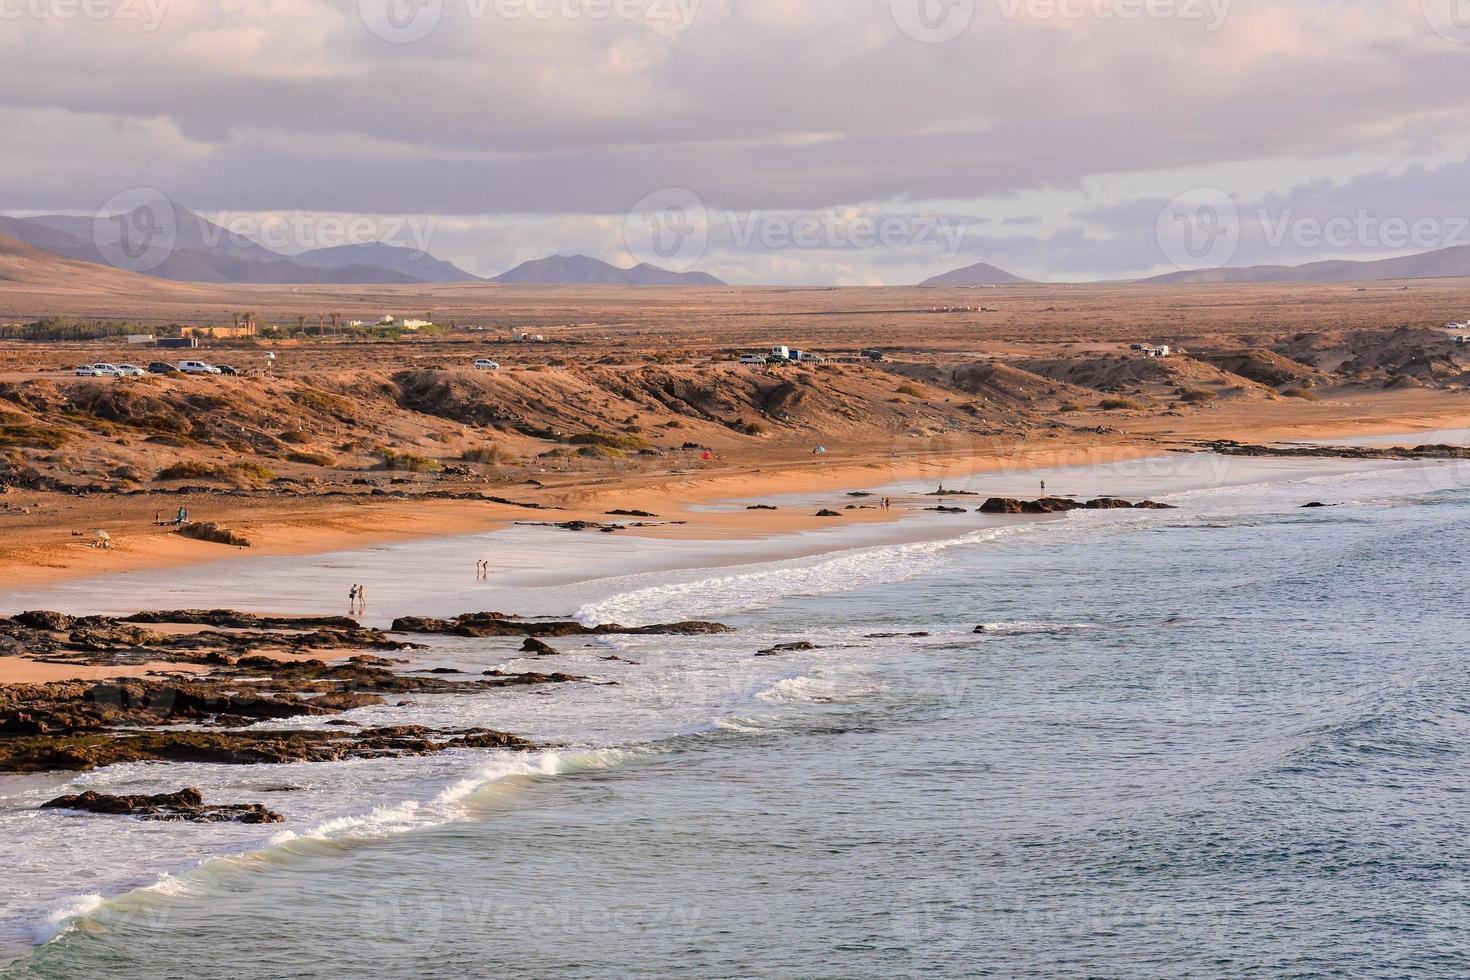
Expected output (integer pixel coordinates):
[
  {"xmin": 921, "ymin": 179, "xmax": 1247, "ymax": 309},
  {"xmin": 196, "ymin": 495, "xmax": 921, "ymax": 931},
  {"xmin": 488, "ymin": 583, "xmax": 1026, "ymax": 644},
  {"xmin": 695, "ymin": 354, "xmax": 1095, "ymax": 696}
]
[{"xmin": 0, "ymin": 467, "xmax": 1470, "ymax": 980}]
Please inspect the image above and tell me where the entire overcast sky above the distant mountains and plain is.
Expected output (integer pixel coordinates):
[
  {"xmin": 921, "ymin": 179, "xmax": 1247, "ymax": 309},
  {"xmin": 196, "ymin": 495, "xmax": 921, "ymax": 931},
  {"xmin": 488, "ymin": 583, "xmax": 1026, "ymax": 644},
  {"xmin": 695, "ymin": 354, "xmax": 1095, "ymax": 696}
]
[{"xmin": 0, "ymin": 0, "xmax": 1470, "ymax": 285}]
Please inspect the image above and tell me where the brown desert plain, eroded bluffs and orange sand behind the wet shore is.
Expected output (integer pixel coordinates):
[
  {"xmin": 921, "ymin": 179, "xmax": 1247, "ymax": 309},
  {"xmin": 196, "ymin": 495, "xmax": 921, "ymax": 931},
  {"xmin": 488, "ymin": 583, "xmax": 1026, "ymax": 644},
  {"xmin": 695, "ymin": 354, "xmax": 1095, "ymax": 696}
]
[{"xmin": 0, "ymin": 262, "xmax": 1470, "ymax": 599}]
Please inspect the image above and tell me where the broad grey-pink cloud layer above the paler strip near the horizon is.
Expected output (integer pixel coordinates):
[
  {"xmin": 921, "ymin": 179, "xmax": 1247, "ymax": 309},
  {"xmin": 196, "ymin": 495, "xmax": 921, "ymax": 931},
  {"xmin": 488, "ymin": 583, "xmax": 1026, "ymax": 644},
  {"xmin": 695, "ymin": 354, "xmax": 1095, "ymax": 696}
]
[{"xmin": 0, "ymin": 0, "xmax": 1470, "ymax": 281}]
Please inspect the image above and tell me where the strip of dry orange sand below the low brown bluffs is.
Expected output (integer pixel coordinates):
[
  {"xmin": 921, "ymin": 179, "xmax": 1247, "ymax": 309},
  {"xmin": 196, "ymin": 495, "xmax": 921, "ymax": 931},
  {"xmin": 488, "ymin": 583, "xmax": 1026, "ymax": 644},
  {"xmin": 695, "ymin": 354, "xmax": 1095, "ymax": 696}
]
[{"xmin": 0, "ymin": 405, "xmax": 1470, "ymax": 597}]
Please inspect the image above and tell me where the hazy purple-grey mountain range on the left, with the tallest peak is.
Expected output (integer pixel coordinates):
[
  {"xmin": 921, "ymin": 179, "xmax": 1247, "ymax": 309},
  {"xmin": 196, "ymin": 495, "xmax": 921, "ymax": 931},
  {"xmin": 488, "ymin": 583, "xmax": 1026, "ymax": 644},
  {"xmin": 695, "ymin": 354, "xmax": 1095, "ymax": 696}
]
[{"xmin": 0, "ymin": 204, "xmax": 723, "ymax": 287}]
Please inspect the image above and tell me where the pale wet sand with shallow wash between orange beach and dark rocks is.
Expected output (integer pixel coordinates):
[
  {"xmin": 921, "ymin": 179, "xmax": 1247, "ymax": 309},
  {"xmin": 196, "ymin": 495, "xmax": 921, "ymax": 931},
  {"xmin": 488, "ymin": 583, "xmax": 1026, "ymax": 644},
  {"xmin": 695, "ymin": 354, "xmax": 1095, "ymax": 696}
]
[{"xmin": 0, "ymin": 437, "xmax": 1458, "ymax": 689}]
